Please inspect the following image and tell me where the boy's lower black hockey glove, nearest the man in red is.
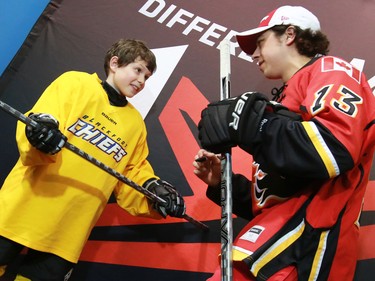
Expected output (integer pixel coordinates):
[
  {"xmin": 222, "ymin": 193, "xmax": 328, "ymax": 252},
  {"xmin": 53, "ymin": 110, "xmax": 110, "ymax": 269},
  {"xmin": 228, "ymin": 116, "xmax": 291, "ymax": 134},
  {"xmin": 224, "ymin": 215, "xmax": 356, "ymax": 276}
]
[{"xmin": 143, "ymin": 179, "xmax": 186, "ymax": 218}]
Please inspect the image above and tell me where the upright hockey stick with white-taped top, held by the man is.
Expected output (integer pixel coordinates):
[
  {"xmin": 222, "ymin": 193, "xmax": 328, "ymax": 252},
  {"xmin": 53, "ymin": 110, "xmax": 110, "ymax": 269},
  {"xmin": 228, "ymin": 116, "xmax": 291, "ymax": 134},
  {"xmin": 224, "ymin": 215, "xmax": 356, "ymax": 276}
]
[{"xmin": 220, "ymin": 40, "xmax": 233, "ymax": 281}]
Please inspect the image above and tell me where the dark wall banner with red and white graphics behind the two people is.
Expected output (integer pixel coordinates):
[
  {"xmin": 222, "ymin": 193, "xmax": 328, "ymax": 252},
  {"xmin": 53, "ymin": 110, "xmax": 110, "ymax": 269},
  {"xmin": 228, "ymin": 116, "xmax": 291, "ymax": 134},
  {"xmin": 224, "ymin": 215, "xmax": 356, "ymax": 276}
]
[{"xmin": 0, "ymin": 0, "xmax": 375, "ymax": 281}]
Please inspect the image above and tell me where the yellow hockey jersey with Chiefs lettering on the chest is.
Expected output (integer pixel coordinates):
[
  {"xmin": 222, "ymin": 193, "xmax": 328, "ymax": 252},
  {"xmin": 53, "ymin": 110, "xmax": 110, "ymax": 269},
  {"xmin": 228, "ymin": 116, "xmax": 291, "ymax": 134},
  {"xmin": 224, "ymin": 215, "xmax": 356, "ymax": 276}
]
[{"xmin": 0, "ymin": 71, "xmax": 161, "ymax": 263}]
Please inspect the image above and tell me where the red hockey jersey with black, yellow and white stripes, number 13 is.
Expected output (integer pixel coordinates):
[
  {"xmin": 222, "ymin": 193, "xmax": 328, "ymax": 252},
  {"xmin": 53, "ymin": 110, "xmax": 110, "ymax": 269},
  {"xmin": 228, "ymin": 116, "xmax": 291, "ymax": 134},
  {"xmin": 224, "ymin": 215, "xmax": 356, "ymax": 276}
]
[{"xmin": 225, "ymin": 56, "xmax": 375, "ymax": 280}]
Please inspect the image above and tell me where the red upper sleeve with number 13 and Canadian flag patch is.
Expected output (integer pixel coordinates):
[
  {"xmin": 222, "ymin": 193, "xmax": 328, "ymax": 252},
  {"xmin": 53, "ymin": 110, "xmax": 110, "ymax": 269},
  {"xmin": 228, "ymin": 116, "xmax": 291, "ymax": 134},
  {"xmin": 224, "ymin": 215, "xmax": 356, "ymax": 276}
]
[{"xmin": 300, "ymin": 56, "xmax": 373, "ymax": 162}]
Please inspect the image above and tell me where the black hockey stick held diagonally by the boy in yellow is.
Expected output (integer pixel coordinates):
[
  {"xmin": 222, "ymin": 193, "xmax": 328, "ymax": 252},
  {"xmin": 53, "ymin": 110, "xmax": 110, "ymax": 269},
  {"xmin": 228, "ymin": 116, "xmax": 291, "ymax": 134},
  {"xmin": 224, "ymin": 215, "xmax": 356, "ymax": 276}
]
[{"xmin": 0, "ymin": 101, "xmax": 208, "ymax": 230}]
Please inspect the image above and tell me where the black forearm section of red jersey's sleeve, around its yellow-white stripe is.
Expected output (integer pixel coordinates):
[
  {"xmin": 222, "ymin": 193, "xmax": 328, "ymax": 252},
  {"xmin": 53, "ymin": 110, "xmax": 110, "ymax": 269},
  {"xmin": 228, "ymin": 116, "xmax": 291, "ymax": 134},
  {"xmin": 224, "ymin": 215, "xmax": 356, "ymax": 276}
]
[{"xmin": 249, "ymin": 112, "xmax": 354, "ymax": 180}]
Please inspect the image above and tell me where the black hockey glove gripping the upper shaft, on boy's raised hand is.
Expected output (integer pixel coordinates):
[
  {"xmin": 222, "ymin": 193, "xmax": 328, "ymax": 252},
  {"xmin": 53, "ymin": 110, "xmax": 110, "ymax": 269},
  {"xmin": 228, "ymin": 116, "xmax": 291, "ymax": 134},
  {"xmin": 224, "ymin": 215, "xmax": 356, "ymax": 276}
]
[{"xmin": 25, "ymin": 113, "xmax": 67, "ymax": 154}]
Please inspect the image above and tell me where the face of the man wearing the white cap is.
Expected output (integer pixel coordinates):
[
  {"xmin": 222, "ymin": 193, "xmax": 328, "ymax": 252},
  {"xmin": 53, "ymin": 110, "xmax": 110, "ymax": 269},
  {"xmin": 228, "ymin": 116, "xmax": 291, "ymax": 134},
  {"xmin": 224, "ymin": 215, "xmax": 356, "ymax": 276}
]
[{"xmin": 252, "ymin": 30, "xmax": 287, "ymax": 79}]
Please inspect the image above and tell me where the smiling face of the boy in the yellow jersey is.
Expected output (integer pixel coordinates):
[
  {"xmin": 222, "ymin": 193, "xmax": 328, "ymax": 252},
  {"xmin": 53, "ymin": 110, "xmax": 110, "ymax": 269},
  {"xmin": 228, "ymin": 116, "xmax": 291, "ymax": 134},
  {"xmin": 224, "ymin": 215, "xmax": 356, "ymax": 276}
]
[{"xmin": 107, "ymin": 57, "xmax": 152, "ymax": 98}]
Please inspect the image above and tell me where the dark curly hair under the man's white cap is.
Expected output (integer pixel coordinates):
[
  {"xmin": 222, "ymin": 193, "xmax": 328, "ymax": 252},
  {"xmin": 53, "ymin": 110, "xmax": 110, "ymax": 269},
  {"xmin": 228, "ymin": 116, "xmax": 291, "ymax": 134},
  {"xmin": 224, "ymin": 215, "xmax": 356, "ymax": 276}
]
[{"xmin": 271, "ymin": 25, "xmax": 329, "ymax": 57}]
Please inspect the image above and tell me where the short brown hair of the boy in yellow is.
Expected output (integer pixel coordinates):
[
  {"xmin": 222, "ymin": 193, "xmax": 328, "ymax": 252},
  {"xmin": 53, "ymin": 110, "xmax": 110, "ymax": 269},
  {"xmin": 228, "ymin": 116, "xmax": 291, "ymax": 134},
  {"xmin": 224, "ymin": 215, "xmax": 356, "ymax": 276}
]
[{"xmin": 104, "ymin": 39, "xmax": 156, "ymax": 76}]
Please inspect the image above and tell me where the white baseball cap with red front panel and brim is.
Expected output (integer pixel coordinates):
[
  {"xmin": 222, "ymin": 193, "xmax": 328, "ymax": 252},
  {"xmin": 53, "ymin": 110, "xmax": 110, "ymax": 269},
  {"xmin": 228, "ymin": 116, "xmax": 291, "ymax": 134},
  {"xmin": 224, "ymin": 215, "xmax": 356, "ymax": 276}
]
[{"xmin": 236, "ymin": 6, "xmax": 320, "ymax": 55}]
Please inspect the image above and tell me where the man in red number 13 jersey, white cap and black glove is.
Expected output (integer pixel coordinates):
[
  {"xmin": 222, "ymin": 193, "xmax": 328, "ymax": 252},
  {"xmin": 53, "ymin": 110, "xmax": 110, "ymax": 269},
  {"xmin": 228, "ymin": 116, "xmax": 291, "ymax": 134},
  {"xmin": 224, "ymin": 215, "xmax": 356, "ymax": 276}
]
[{"xmin": 193, "ymin": 6, "xmax": 375, "ymax": 281}]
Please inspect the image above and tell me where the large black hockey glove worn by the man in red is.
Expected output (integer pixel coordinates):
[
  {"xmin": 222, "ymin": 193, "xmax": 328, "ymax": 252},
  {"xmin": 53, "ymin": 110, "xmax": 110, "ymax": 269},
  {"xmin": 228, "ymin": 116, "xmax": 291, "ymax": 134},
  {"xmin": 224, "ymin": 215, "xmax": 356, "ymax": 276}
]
[{"xmin": 198, "ymin": 92, "xmax": 269, "ymax": 153}]
